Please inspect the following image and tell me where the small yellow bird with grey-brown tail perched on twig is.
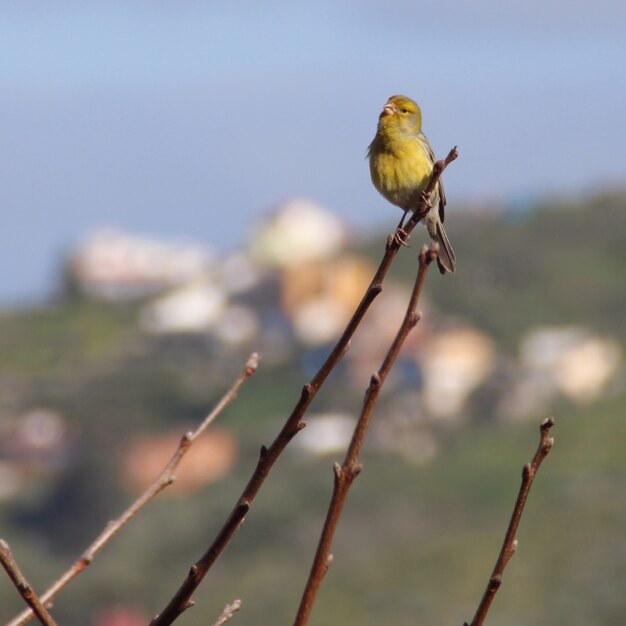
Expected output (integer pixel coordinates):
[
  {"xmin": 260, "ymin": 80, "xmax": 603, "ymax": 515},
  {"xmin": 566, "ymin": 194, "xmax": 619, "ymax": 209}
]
[{"xmin": 367, "ymin": 95, "xmax": 456, "ymax": 274}]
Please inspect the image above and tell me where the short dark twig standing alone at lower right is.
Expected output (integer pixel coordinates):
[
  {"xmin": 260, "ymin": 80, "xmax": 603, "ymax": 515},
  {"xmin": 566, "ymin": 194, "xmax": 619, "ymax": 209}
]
[{"xmin": 464, "ymin": 417, "xmax": 554, "ymax": 626}]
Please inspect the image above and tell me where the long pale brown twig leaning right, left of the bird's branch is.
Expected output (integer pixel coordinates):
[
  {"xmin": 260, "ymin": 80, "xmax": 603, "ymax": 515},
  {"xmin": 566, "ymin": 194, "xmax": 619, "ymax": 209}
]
[{"xmin": 7, "ymin": 352, "xmax": 259, "ymax": 626}]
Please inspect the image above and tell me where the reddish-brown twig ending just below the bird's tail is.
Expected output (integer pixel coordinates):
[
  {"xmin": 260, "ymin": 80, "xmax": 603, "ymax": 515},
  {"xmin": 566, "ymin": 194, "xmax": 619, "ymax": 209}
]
[{"xmin": 294, "ymin": 246, "xmax": 437, "ymax": 626}]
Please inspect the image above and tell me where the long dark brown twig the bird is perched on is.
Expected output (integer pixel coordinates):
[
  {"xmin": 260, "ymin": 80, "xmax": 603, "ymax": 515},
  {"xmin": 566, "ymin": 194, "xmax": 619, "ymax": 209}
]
[{"xmin": 150, "ymin": 146, "xmax": 459, "ymax": 626}]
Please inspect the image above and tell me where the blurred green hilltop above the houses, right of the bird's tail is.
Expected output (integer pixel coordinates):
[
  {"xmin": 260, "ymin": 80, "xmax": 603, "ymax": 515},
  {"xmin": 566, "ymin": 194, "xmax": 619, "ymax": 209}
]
[{"xmin": 368, "ymin": 188, "xmax": 626, "ymax": 350}]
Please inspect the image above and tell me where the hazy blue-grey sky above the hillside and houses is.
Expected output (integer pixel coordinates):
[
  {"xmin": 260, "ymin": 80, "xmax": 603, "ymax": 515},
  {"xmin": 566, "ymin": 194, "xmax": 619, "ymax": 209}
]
[{"xmin": 0, "ymin": 0, "xmax": 626, "ymax": 303}]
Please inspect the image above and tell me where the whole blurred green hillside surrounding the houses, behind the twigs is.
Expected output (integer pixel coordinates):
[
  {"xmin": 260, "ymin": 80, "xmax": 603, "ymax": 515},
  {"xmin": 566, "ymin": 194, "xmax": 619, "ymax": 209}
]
[{"xmin": 0, "ymin": 194, "xmax": 626, "ymax": 626}]
